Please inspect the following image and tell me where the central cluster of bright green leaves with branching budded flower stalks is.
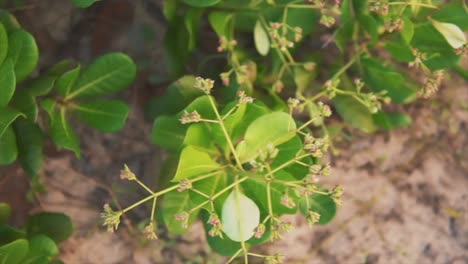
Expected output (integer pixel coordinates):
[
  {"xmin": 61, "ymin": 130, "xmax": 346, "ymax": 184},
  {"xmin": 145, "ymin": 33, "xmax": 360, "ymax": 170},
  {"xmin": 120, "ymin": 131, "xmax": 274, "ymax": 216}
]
[{"xmin": 102, "ymin": 76, "xmax": 342, "ymax": 261}]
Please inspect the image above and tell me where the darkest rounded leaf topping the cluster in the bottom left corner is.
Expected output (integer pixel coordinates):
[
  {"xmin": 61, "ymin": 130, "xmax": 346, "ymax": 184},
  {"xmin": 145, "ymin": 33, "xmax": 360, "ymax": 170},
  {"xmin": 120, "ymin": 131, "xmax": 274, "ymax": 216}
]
[{"xmin": 26, "ymin": 212, "xmax": 73, "ymax": 243}]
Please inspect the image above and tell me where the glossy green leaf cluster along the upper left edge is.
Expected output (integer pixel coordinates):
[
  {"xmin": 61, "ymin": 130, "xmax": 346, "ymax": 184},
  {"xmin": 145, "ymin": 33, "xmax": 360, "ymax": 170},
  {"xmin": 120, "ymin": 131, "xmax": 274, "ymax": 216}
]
[{"xmin": 0, "ymin": 11, "xmax": 136, "ymax": 187}]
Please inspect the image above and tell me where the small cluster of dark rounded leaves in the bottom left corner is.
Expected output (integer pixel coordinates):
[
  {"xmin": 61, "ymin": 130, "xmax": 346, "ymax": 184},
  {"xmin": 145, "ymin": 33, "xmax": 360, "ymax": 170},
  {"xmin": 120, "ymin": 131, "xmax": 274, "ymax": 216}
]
[{"xmin": 0, "ymin": 203, "xmax": 73, "ymax": 264}]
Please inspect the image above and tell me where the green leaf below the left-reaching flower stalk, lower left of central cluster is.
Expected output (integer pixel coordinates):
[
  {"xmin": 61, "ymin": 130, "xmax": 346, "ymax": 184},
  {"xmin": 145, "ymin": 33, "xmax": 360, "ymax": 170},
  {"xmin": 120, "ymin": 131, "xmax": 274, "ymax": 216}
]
[{"xmin": 161, "ymin": 187, "xmax": 200, "ymax": 235}]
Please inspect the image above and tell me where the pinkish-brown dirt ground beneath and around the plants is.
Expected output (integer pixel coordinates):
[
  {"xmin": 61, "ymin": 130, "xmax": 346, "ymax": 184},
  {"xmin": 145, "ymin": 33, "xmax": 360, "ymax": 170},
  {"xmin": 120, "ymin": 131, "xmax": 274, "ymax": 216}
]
[{"xmin": 0, "ymin": 0, "xmax": 468, "ymax": 264}]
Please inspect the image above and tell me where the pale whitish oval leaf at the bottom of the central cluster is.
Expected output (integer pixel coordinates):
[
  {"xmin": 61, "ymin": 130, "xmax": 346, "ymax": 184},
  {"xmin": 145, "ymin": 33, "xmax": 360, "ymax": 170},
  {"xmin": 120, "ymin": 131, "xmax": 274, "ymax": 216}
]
[{"xmin": 221, "ymin": 190, "xmax": 260, "ymax": 242}]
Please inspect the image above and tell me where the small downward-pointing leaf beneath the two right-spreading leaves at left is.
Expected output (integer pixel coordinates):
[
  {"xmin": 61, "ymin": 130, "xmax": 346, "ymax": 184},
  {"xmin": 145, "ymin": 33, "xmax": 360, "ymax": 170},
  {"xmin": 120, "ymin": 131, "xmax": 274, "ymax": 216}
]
[{"xmin": 50, "ymin": 108, "xmax": 80, "ymax": 157}]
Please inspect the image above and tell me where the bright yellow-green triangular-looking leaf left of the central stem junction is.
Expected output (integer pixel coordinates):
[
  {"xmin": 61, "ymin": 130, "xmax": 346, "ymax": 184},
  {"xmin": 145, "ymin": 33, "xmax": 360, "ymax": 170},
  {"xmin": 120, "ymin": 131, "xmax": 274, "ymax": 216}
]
[{"xmin": 172, "ymin": 146, "xmax": 221, "ymax": 182}]
